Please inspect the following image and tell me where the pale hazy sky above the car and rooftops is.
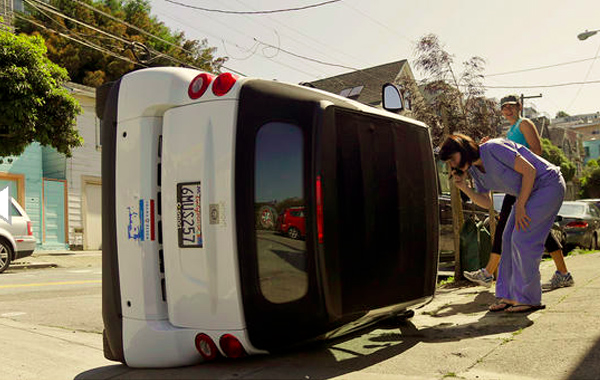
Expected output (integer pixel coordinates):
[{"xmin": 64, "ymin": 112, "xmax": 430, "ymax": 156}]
[{"xmin": 150, "ymin": 0, "xmax": 600, "ymax": 117}]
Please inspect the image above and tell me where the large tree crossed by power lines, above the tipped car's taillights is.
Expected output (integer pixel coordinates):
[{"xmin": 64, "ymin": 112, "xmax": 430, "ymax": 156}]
[{"xmin": 16, "ymin": 0, "xmax": 226, "ymax": 87}]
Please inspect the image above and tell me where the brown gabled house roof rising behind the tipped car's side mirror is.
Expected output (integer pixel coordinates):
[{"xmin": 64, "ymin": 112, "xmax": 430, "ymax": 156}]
[{"xmin": 310, "ymin": 59, "xmax": 414, "ymax": 108}]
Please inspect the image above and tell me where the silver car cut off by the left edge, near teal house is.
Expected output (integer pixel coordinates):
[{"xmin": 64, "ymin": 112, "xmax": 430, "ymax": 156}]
[{"xmin": 0, "ymin": 198, "xmax": 35, "ymax": 273}]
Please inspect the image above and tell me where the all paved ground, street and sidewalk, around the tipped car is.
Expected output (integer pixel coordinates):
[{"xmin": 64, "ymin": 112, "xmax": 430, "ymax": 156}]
[{"xmin": 0, "ymin": 249, "xmax": 600, "ymax": 380}]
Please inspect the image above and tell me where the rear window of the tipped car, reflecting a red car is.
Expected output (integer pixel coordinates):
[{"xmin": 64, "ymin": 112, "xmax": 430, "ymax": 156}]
[{"xmin": 254, "ymin": 122, "xmax": 308, "ymax": 303}]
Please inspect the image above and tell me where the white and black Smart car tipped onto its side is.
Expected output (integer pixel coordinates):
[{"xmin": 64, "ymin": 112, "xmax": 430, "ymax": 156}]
[{"xmin": 97, "ymin": 68, "xmax": 438, "ymax": 367}]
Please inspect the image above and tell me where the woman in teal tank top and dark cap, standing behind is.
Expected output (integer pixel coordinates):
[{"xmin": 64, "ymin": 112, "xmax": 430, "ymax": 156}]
[{"xmin": 463, "ymin": 95, "xmax": 574, "ymax": 290}]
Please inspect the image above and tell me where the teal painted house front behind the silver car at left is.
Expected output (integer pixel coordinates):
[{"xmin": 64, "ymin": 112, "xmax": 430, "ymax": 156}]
[{"xmin": 0, "ymin": 143, "xmax": 68, "ymax": 250}]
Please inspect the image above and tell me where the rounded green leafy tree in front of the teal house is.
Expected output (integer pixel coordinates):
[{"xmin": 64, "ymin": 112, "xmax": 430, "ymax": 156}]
[{"xmin": 0, "ymin": 30, "xmax": 83, "ymax": 157}]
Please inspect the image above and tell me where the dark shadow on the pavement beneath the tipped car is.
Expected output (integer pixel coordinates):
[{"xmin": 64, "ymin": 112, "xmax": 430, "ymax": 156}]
[{"xmin": 75, "ymin": 313, "xmax": 533, "ymax": 380}]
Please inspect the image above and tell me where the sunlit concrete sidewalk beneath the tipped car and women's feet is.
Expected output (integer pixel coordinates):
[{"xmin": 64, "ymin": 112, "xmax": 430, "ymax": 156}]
[{"xmin": 0, "ymin": 253, "xmax": 600, "ymax": 380}]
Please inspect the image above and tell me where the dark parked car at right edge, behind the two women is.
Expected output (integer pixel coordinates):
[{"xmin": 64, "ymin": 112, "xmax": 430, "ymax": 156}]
[{"xmin": 558, "ymin": 201, "xmax": 600, "ymax": 249}]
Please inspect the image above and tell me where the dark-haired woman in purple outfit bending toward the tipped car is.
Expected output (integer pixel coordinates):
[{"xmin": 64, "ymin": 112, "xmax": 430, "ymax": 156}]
[{"xmin": 440, "ymin": 134, "xmax": 565, "ymax": 312}]
